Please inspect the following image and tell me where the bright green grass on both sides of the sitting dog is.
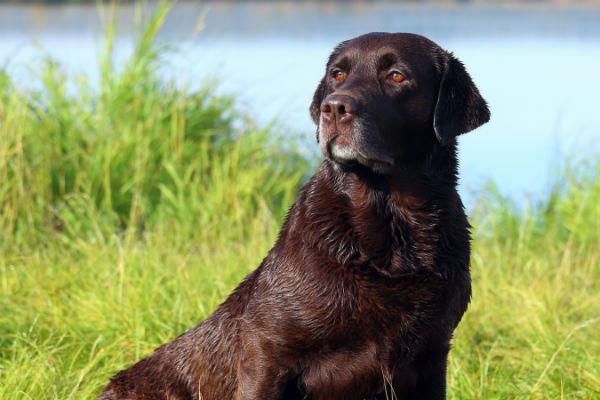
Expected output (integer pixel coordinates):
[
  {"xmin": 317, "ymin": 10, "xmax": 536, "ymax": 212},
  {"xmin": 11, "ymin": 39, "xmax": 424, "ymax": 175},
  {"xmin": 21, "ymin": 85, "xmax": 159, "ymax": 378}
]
[{"xmin": 0, "ymin": 3, "xmax": 600, "ymax": 400}]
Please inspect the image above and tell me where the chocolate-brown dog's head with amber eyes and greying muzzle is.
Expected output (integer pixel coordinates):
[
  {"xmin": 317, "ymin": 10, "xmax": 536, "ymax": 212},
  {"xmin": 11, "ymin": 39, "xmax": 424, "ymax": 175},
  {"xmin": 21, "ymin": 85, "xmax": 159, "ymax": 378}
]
[{"xmin": 310, "ymin": 33, "xmax": 490, "ymax": 174}]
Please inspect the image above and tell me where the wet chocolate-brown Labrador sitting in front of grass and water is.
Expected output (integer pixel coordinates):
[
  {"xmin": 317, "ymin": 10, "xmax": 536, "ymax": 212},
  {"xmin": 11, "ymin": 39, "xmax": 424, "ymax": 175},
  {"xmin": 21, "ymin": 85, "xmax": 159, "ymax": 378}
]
[{"xmin": 100, "ymin": 33, "xmax": 490, "ymax": 400}]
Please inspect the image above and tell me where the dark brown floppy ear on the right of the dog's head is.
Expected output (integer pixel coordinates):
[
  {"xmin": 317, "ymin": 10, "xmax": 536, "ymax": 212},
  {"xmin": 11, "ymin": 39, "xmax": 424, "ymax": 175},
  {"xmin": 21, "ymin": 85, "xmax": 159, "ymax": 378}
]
[{"xmin": 433, "ymin": 53, "xmax": 490, "ymax": 144}]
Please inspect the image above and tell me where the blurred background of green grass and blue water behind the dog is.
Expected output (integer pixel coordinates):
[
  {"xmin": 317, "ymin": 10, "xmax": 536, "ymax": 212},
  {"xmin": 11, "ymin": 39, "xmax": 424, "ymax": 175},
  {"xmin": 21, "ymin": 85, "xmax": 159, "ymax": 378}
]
[{"xmin": 0, "ymin": 0, "xmax": 600, "ymax": 400}]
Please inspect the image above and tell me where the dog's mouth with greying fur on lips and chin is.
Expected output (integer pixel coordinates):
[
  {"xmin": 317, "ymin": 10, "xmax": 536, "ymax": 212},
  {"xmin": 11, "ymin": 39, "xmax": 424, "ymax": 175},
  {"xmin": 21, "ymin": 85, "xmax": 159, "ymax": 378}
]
[{"xmin": 327, "ymin": 134, "xmax": 394, "ymax": 174}]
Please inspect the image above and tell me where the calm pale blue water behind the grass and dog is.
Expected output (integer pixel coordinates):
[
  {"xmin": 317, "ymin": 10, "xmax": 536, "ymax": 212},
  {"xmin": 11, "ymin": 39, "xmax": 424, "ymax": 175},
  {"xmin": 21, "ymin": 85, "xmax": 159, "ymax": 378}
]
[{"xmin": 0, "ymin": 3, "xmax": 600, "ymax": 205}]
